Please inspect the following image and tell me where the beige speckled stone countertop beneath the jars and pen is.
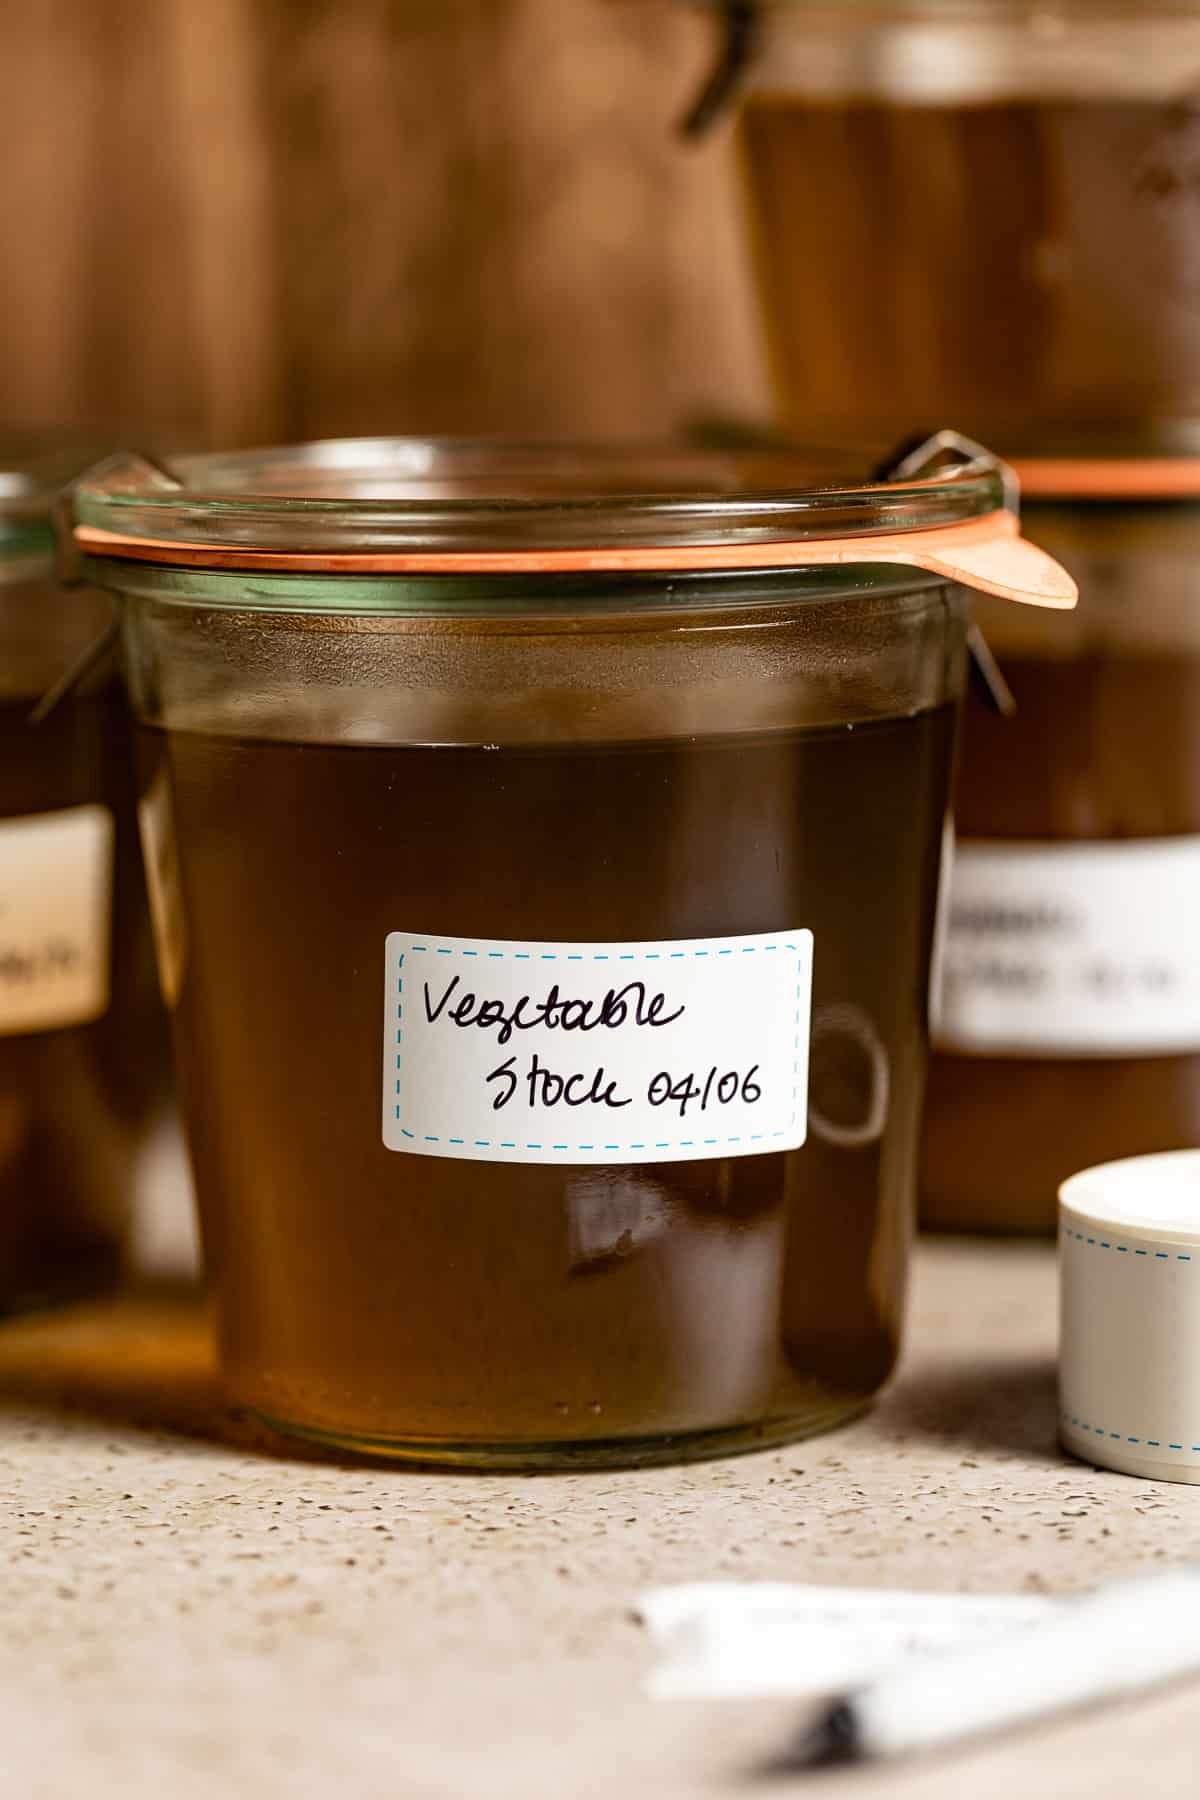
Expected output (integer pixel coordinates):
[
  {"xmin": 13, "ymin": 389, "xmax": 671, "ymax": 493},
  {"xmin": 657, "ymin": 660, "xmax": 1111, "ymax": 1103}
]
[{"xmin": 0, "ymin": 1244, "xmax": 1200, "ymax": 1800}]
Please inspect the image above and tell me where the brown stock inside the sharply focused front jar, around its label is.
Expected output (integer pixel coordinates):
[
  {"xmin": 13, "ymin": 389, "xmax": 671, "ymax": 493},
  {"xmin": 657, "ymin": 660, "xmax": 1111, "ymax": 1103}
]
[{"xmin": 148, "ymin": 707, "xmax": 952, "ymax": 1460}]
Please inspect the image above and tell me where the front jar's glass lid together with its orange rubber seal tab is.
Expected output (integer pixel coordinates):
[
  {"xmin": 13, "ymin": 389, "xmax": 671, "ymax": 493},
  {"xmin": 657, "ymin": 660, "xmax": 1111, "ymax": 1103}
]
[{"xmin": 72, "ymin": 437, "xmax": 1074, "ymax": 607}]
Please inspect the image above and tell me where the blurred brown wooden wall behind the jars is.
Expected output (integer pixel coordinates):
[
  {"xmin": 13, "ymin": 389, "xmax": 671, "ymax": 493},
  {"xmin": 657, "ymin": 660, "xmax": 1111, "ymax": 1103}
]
[{"xmin": 0, "ymin": 0, "xmax": 763, "ymax": 443}]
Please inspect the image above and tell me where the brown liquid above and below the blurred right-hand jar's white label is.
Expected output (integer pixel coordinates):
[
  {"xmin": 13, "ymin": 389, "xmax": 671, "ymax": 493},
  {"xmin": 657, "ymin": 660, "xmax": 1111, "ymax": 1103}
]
[{"xmin": 921, "ymin": 655, "xmax": 1200, "ymax": 1231}]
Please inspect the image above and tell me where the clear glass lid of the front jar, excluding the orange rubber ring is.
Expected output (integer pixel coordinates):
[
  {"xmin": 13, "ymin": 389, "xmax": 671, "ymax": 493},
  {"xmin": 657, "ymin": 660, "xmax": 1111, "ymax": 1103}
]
[{"xmin": 72, "ymin": 437, "xmax": 1004, "ymax": 565}]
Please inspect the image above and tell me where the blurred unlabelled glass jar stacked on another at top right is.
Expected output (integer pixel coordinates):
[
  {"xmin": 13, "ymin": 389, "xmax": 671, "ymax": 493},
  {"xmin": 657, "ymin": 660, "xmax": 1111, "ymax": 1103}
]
[{"xmin": 739, "ymin": 0, "xmax": 1200, "ymax": 443}]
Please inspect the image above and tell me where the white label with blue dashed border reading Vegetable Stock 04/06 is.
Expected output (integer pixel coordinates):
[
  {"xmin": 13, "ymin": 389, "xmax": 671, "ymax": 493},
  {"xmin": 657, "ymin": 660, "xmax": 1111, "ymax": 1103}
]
[{"xmin": 383, "ymin": 931, "xmax": 813, "ymax": 1163}]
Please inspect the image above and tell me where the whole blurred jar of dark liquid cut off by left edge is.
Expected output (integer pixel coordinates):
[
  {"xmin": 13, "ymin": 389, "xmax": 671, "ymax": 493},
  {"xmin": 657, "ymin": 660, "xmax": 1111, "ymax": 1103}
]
[{"xmin": 0, "ymin": 441, "xmax": 167, "ymax": 1312}]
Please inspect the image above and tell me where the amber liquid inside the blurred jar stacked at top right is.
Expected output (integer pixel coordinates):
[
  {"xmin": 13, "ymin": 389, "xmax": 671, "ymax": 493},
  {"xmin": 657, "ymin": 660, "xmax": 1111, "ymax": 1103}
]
[{"xmin": 741, "ymin": 94, "xmax": 1200, "ymax": 439}]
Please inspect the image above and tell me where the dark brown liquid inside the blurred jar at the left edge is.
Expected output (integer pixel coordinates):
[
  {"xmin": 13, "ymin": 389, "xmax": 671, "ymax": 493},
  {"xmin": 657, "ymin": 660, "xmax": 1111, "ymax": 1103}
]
[{"xmin": 0, "ymin": 684, "xmax": 167, "ymax": 1310}]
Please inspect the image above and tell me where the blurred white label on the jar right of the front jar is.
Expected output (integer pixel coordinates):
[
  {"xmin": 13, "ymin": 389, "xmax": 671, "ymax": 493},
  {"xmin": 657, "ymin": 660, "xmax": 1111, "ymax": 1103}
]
[{"xmin": 934, "ymin": 837, "xmax": 1200, "ymax": 1057}]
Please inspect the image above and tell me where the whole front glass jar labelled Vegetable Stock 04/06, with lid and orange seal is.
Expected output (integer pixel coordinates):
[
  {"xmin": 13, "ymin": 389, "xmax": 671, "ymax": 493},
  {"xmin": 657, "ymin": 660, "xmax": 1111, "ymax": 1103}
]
[{"xmin": 76, "ymin": 441, "xmax": 1069, "ymax": 1465}]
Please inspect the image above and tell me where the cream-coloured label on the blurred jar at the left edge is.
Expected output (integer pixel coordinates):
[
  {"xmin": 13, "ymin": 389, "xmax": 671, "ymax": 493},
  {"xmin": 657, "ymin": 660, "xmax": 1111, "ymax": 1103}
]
[{"xmin": 0, "ymin": 806, "xmax": 113, "ymax": 1037}]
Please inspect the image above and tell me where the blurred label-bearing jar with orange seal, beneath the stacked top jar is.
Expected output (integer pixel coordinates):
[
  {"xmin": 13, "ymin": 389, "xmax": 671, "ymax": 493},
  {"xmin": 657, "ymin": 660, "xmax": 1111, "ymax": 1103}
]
[{"xmin": 921, "ymin": 443, "xmax": 1200, "ymax": 1231}]
